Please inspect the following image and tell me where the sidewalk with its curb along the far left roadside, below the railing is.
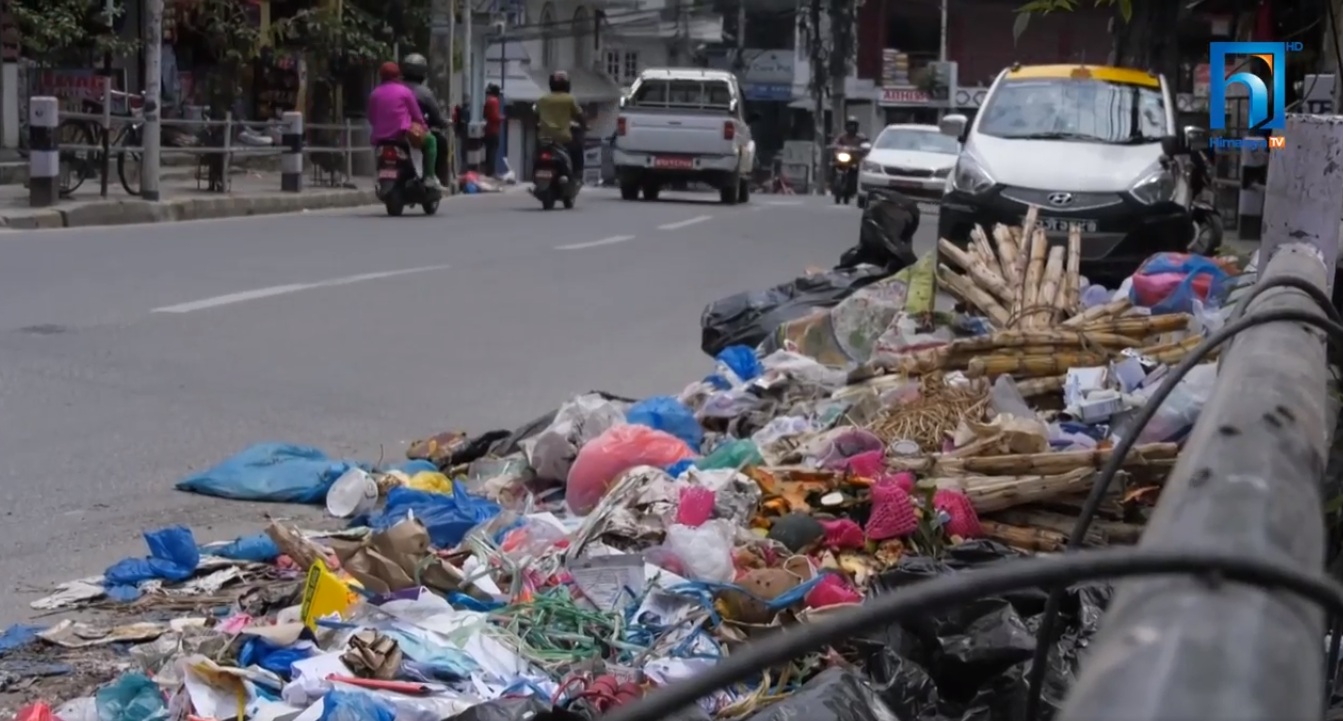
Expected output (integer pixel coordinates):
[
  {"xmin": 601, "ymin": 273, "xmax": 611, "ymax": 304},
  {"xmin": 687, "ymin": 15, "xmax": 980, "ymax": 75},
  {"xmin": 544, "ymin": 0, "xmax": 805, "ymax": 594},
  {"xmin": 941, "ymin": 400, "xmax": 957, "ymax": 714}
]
[{"xmin": 0, "ymin": 172, "xmax": 377, "ymax": 230}]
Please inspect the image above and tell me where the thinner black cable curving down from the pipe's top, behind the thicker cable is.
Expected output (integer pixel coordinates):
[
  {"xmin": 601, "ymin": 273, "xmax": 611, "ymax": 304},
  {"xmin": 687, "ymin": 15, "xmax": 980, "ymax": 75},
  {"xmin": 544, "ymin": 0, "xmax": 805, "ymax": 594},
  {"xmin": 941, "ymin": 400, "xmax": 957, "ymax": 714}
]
[{"xmin": 1026, "ymin": 300, "xmax": 1343, "ymax": 721}]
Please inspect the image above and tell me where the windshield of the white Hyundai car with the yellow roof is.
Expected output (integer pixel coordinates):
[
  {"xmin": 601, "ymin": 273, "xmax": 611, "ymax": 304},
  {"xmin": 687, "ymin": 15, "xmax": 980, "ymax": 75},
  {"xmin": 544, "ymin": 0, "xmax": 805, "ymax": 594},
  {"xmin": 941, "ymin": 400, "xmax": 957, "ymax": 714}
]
[{"xmin": 978, "ymin": 78, "xmax": 1167, "ymax": 144}]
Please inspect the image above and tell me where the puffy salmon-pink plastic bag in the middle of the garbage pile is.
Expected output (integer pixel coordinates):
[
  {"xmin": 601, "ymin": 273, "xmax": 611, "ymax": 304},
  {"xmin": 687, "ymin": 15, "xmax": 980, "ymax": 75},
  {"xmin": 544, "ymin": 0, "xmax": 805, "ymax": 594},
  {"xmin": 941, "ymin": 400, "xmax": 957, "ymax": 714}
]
[{"xmin": 564, "ymin": 423, "xmax": 694, "ymax": 516}]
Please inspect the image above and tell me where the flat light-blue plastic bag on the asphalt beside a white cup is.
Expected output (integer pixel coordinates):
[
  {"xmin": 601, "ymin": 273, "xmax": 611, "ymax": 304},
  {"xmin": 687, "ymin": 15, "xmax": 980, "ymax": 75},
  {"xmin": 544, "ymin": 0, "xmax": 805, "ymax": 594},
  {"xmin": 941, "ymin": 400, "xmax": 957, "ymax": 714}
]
[{"xmin": 177, "ymin": 443, "xmax": 351, "ymax": 503}]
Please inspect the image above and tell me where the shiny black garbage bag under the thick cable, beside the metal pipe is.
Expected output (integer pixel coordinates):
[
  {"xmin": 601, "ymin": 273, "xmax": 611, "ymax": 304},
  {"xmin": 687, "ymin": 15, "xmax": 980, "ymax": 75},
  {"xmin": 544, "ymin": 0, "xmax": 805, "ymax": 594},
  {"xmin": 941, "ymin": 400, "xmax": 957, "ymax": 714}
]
[{"xmin": 854, "ymin": 541, "xmax": 1111, "ymax": 721}]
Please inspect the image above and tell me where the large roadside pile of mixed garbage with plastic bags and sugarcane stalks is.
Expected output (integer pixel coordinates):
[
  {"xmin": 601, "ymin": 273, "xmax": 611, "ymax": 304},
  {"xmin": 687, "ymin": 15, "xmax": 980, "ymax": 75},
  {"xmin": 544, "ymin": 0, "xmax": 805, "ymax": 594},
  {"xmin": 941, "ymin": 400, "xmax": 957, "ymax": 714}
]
[{"xmin": 0, "ymin": 218, "xmax": 1253, "ymax": 721}]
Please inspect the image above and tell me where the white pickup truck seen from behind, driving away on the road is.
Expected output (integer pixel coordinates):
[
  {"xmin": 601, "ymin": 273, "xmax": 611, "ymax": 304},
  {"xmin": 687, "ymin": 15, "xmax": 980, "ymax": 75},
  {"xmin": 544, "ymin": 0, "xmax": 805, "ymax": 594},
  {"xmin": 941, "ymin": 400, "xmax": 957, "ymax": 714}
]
[{"xmin": 614, "ymin": 67, "xmax": 755, "ymax": 205}]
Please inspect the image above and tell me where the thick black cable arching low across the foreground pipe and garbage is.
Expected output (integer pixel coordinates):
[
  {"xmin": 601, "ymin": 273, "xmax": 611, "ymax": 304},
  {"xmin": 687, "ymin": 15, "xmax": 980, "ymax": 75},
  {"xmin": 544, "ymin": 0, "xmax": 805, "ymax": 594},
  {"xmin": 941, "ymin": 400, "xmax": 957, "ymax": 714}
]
[{"xmin": 602, "ymin": 548, "xmax": 1343, "ymax": 721}]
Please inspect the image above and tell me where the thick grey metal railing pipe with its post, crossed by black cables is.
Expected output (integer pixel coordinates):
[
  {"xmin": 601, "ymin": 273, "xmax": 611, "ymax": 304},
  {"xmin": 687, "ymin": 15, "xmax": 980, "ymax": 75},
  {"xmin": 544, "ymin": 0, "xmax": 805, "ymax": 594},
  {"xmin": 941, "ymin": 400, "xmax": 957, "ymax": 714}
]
[{"xmin": 1060, "ymin": 115, "xmax": 1343, "ymax": 721}]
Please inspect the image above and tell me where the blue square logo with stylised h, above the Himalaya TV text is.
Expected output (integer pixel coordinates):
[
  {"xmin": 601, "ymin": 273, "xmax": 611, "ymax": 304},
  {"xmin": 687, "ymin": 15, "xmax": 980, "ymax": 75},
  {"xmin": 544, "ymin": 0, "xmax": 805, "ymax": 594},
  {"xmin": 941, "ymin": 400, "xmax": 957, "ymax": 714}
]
[{"xmin": 1207, "ymin": 42, "xmax": 1301, "ymax": 130}]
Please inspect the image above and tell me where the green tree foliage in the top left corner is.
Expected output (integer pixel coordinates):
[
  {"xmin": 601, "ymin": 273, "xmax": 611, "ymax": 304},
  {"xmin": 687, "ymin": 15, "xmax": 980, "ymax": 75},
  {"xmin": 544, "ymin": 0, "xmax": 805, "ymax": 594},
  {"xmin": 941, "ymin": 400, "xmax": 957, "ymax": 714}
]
[{"xmin": 9, "ymin": 0, "xmax": 140, "ymax": 66}]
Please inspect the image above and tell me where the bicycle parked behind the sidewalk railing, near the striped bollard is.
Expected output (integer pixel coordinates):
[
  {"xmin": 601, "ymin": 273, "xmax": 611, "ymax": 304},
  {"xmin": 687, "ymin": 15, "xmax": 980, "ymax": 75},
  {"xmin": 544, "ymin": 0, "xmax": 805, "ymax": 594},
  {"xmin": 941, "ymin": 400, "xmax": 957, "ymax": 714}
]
[{"xmin": 56, "ymin": 90, "xmax": 145, "ymax": 196}]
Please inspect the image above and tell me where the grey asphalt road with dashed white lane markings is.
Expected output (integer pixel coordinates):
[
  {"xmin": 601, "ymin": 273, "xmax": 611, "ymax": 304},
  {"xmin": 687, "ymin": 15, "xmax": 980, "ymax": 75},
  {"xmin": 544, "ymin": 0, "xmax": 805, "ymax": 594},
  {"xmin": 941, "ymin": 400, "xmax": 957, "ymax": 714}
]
[{"xmin": 0, "ymin": 189, "xmax": 935, "ymax": 626}]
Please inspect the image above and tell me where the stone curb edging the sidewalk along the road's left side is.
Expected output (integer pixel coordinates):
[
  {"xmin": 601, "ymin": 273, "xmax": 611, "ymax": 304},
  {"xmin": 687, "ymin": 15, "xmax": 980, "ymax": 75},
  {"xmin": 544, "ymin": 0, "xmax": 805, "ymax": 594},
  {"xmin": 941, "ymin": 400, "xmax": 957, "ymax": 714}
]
[{"xmin": 0, "ymin": 189, "xmax": 377, "ymax": 230}]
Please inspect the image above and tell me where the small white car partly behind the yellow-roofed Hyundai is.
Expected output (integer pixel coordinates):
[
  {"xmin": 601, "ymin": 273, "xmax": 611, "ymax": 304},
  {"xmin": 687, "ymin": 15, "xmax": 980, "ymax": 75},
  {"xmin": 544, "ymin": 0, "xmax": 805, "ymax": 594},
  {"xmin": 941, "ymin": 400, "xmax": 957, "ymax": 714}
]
[{"xmin": 858, "ymin": 125, "xmax": 960, "ymax": 208}]
